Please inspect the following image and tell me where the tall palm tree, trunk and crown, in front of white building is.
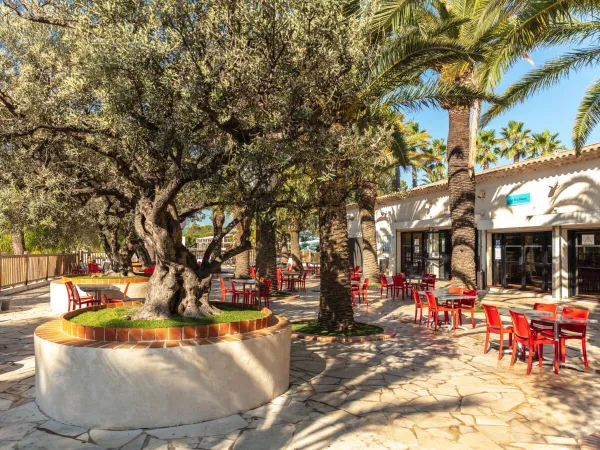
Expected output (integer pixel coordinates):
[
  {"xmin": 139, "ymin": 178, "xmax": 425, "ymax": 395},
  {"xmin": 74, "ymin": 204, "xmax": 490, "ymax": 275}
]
[{"xmin": 373, "ymin": 0, "xmax": 528, "ymax": 288}]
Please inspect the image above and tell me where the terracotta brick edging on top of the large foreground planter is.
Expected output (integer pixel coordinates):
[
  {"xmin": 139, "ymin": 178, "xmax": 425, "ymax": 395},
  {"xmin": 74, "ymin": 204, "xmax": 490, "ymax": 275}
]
[{"xmin": 35, "ymin": 301, "xmax": 289, "ymax": 348}]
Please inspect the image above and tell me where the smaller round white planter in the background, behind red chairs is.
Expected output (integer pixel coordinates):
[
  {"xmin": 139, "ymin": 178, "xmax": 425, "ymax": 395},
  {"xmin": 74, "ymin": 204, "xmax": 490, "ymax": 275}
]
[{"xmin": 50, "ymin": 276, "xmax": 149, "ymax": 314}]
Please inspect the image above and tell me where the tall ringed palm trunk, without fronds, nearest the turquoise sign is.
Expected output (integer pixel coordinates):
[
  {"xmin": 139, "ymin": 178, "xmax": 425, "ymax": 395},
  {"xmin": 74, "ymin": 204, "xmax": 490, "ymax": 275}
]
[{"xmin": 447, "ymin": 105, "xmax": 475, "ymax": 289}]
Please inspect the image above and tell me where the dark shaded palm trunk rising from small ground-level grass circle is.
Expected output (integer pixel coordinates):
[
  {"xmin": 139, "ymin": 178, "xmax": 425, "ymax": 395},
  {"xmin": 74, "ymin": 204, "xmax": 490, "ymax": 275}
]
[{"xmin": 318, "ymin": 169, "xmax": 355, "ymax": 330}]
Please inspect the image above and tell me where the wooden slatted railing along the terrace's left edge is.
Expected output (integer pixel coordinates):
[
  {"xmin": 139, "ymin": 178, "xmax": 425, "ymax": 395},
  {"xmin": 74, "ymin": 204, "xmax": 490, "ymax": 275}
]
[{"xmin": 0, "ymin": 252, "xmax": 105, "ymax": 289}]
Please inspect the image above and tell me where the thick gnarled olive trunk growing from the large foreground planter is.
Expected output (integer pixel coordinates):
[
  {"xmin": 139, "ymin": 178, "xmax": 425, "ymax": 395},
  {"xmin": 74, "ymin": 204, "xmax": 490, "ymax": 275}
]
[{"xmin": 135, "ymin": 199, "xmax": 220, "ymax": 320}]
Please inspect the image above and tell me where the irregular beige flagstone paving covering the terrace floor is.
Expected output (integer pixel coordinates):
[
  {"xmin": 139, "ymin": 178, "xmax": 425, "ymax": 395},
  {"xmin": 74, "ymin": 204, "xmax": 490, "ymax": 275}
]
[{"xmin": 0, "ymin": 280, "xmax": 600, "ymax": 450}]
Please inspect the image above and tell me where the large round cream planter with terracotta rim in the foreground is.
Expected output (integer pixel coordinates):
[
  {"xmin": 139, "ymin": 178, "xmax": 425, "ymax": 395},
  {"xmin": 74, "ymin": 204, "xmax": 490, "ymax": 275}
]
[{"xmin": 35, "ymin": 303, "xmax": 291, "ymax": 428}]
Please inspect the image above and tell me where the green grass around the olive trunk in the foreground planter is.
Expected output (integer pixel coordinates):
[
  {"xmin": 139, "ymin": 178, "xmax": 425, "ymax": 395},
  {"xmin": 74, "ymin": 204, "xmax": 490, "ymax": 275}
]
[{"xmin": 70, "ymin": 303, "xmax": 266, "ymax": 328}]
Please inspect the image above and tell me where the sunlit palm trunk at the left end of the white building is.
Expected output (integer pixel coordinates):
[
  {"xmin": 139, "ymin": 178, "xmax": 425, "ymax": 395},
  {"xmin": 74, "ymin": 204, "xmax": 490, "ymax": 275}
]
[{"xmin": 356, "ymin": 181, "xmax": 379, "ymax": 282}]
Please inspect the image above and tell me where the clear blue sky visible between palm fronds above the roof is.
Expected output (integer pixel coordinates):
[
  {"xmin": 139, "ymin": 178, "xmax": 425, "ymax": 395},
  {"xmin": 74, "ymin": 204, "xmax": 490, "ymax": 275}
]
[{"xmin": 402, "ymin": 47, "xmax": 600, "ymax": 185}]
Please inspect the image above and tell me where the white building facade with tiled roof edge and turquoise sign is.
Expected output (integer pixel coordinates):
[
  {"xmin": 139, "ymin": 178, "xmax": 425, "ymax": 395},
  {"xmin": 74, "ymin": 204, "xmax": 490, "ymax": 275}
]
[{"xmin": 348, "ymin": 144, "xmax": 600, "ymax": 299}]
